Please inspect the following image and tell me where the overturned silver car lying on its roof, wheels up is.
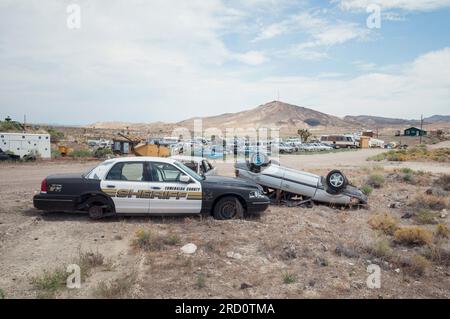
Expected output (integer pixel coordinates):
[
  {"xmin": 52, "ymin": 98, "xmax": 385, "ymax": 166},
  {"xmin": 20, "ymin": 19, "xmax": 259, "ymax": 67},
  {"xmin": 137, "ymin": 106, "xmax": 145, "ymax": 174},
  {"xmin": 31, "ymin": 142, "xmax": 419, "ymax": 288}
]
[{"xmin": 235, "ymin": 160, "xmax": 367, "ymax": 205}]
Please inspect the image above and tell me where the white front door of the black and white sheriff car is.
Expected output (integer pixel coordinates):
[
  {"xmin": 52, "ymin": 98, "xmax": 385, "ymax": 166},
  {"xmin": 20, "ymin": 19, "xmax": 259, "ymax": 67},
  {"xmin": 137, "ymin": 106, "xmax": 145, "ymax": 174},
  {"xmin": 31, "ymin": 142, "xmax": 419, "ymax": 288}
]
[{"xmin": 149, "ymin": 162, "xmax": 202, "ymax": 214}]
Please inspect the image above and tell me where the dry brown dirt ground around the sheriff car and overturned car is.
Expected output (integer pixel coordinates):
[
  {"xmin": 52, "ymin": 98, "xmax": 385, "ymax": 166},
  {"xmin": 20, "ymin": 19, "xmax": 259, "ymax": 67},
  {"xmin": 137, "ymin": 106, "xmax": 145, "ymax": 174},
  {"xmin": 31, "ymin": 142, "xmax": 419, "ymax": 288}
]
[{"xmin": 0, "ymin": 150, "xmax": 450, "ymax": 298}]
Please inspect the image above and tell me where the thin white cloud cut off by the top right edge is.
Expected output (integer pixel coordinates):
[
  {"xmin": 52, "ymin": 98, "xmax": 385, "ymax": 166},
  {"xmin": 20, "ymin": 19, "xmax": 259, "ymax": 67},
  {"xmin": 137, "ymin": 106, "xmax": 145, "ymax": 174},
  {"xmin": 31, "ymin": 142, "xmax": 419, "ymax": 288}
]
[{"xmin": 333, "ymin": 0, "xmax": 450, "ymax": 11}]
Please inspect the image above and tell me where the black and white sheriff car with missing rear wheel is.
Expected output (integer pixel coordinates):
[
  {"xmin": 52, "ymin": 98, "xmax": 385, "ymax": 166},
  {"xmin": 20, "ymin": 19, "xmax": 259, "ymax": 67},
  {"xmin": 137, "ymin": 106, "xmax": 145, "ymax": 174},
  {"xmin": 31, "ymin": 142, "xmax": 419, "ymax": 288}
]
[{"xmin": 33, "ymin": 157, "xmax": 269, "ymax": 219}]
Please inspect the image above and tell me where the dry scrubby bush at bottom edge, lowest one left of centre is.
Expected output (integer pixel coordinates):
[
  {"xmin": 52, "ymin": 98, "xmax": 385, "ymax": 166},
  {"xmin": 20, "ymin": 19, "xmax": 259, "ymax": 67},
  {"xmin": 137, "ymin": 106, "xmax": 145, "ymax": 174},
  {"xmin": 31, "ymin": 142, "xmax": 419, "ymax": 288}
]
[{"xmin": 94, "ymin": 272, "xmax": 137, "ymax": 299}]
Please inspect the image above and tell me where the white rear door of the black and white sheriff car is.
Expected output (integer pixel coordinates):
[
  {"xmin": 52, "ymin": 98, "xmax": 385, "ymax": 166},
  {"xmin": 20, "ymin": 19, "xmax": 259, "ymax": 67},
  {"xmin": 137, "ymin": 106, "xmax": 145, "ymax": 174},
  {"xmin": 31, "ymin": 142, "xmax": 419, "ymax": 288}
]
[{"xmin": 100, "ymin": 162, "xmax": 151, "ymax": 214}]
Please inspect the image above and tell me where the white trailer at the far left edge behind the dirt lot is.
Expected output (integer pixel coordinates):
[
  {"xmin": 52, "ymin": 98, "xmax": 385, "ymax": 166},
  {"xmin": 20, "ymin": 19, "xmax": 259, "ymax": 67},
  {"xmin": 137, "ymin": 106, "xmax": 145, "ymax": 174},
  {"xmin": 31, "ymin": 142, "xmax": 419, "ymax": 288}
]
[{"xmin": 0, "ymin": 133, "xmax": 51, "ymax": 159}]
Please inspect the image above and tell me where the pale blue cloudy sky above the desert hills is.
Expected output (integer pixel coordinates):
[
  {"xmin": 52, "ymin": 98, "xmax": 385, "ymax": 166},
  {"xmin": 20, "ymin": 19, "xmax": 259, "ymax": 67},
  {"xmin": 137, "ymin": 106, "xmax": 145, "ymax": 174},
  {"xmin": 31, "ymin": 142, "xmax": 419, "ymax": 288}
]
[{"xmin": 0, "ymin": 0, "xmax": 450, "ymax": 124}]
